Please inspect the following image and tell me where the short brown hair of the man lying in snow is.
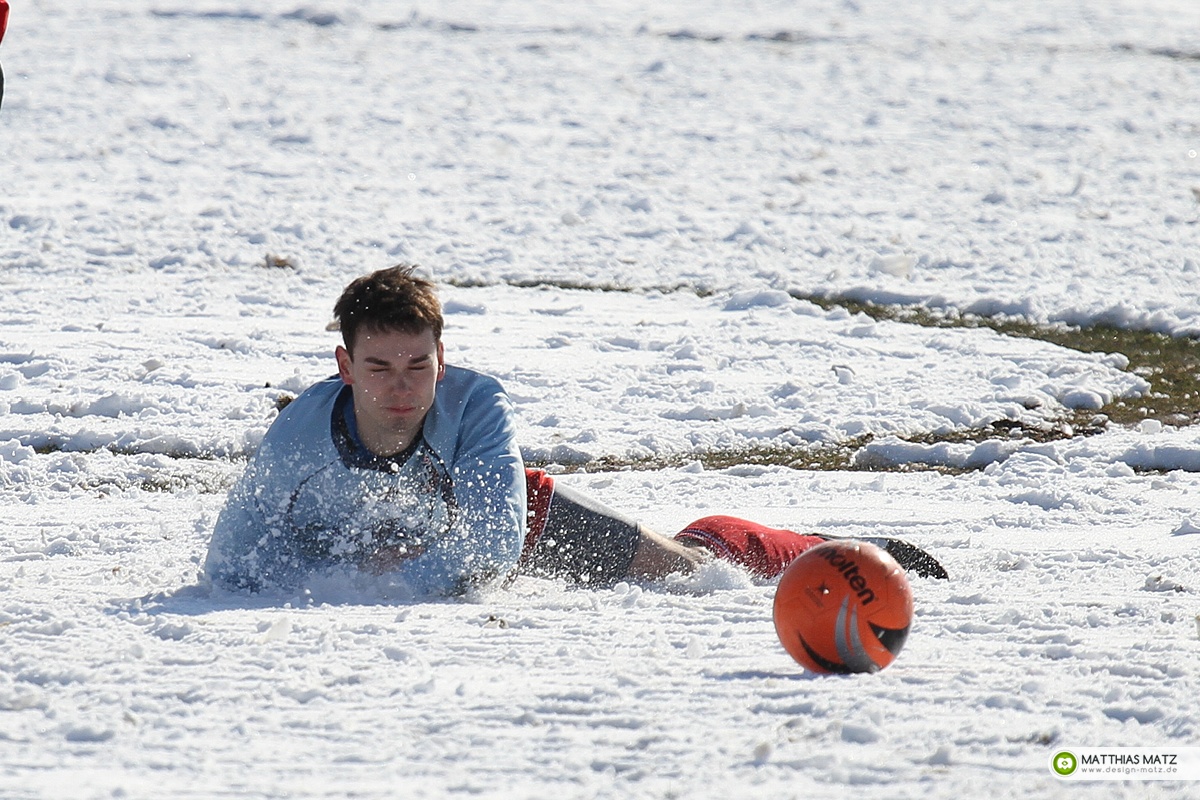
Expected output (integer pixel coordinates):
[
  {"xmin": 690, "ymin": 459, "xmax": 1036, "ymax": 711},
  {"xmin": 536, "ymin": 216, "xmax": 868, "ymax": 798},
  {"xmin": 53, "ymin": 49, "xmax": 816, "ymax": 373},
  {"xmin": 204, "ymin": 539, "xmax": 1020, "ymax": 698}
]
[{"xmin": 334, "ymin": 264, "xmax": 443, "ymax": 355}]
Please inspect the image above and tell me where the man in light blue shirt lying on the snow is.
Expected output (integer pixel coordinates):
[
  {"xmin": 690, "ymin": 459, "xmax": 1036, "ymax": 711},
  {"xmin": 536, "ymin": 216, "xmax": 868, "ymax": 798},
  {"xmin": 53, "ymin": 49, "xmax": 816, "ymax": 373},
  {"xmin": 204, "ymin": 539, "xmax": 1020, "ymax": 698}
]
[{"xmin": 205, "ymin": 266, "xmax": 946, "ymax": 595}]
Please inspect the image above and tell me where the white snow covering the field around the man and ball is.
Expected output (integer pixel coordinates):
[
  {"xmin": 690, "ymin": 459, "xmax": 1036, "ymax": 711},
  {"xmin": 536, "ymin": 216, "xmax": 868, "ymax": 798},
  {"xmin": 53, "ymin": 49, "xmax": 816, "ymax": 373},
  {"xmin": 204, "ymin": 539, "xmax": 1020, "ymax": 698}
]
[{"xmin": 0, "ymin": 0, "xmax": 1200, "ymax": 799}]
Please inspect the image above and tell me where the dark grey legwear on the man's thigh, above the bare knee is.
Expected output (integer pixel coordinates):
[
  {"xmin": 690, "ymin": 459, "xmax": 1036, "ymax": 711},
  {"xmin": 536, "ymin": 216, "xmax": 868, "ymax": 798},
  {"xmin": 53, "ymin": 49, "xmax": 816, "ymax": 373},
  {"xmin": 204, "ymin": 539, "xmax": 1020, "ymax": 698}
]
[{"xmin": 521, "ymin": 482, "xmax": 641, "ymax": 585}]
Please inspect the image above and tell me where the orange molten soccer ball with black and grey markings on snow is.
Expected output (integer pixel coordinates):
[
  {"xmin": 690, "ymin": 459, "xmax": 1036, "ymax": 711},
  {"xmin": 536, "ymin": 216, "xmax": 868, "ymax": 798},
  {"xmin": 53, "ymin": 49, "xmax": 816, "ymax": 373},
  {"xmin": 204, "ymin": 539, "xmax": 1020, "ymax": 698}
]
[{"xmin": 774, "ymin": 540, "xmax": 912, "ymax": 673}]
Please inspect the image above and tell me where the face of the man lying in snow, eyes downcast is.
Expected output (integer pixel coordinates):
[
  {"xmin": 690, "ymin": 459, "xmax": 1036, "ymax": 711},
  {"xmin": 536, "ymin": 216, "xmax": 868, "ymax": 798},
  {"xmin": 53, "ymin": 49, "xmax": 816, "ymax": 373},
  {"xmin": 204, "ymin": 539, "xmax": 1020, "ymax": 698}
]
[{"xmin": 337, "ymin": 329, "xmax": 445, "ymax": 456}]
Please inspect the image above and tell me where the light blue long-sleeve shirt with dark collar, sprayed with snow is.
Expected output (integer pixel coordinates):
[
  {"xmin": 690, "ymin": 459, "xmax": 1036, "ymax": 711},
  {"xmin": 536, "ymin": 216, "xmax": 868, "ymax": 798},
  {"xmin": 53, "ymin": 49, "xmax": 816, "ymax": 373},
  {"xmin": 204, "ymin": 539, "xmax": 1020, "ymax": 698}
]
[{"xmin": 205, "ymin": 367, "xmax": 526, "ymax": 595}]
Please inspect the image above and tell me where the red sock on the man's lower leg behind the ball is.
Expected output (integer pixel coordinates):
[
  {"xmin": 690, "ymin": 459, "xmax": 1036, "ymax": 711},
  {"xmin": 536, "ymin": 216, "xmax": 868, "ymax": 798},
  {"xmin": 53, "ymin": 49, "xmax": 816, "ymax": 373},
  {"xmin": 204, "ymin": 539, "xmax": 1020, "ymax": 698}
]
[{"xmin": 676, "ymin": 516, "xmax": 826, "ymax": 578}]
